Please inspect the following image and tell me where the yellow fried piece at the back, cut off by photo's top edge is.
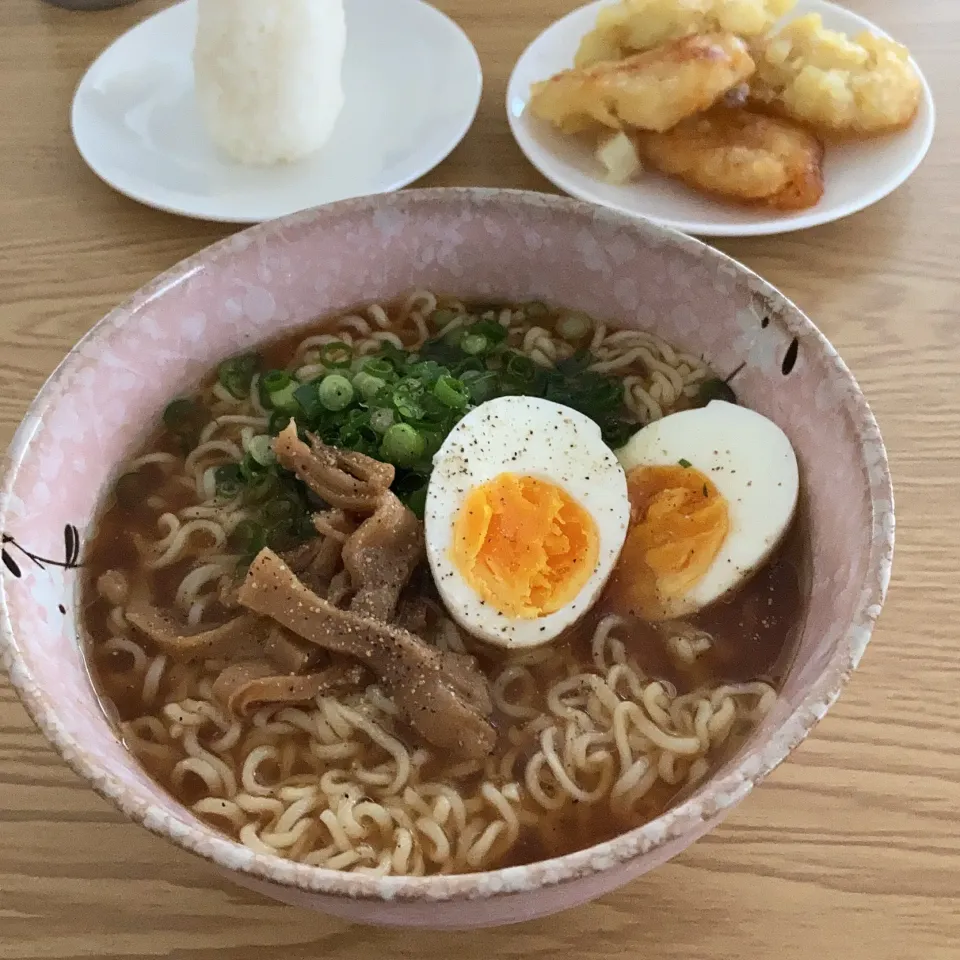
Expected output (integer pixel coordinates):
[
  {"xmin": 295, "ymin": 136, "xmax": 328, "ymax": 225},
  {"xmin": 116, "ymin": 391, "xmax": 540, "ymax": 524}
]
[{"xmin": 574, "ymin": 0, "xmax": 796, "ymax": 67}]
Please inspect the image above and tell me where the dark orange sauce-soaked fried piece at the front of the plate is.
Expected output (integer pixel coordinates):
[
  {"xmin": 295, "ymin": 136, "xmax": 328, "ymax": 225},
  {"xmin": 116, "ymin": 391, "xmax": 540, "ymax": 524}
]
[{"xmin": 637, "ymin": 109, "xmax": 823, "ymax": 210}]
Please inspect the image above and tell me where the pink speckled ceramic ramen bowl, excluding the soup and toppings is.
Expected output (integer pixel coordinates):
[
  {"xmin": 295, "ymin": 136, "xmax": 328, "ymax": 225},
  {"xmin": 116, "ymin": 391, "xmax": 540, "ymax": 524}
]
[{"xmin": 0, "ymin": 190, "xmax": 893, "ymax": 927}]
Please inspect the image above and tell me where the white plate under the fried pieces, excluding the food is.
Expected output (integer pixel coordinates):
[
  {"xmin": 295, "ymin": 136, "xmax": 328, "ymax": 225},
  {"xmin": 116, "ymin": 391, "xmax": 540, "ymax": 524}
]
[{"xmin": 507, "ymin": 0, "xmax": 934, "ymax": 237}]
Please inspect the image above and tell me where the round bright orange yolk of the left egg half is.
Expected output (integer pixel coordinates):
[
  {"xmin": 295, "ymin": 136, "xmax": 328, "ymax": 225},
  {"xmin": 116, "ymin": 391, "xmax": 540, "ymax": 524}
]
[{"xmin": 451, "ymin": 473, "xmax": 600, "ymax": 620}]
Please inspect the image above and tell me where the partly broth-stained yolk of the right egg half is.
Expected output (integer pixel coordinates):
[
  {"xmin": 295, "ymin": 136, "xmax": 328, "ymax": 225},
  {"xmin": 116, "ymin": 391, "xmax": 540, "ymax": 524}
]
[{"xmin": 610, "ymin": 466, "xmax": 730, "ymax": 621}]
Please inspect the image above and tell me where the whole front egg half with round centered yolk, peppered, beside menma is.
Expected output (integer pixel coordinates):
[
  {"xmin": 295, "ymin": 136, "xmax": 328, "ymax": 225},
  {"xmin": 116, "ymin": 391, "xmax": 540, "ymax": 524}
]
[{"xmin": 424, "ymin": 396, "xmax": 630, "ymax": 649}]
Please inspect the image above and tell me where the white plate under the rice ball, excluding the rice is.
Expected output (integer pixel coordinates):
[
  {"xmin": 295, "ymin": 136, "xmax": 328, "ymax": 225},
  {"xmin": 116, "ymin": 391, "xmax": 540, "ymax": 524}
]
[{"xmin": 72, "ymin": 0, "xmax": 482, "ymax": 223}]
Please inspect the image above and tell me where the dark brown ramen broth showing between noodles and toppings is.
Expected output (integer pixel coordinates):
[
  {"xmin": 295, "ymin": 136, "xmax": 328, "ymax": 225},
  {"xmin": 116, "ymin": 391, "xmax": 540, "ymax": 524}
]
[{"xmin": 82, "ymin": 305, "xmax": 805, "ymax": 865}]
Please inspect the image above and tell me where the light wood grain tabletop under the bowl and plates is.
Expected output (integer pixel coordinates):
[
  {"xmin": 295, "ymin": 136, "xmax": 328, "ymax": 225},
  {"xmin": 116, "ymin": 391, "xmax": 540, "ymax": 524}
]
[{"xmin": 0, "ymin": 0, "xmax": 960, "ymax": 960}]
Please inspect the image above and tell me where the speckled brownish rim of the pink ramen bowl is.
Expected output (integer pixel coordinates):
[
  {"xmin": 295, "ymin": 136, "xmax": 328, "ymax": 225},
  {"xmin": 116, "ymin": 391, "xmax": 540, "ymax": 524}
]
[{"xmin": 0, "ymin": 187, "xmax": 894, "ymax": 903}]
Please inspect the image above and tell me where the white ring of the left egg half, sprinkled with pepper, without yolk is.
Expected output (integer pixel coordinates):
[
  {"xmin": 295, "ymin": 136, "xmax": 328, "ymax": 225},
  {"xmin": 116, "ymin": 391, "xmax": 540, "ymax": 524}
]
[{"xmin": 424, "ymin": 397, "xmax": 630, "ymax": 649}]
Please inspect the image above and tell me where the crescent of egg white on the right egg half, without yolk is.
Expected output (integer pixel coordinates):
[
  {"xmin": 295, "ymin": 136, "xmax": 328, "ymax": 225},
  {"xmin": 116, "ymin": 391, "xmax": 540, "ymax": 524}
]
[{"xmin": 617, "ymin": 400, "xmax": 800, "ymax": 617}]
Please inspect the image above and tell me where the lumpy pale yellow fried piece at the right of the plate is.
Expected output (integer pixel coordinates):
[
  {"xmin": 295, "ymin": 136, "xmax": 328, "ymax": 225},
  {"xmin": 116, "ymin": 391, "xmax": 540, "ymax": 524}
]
[{"xmin": 751, "ymin": 13, "xmax": 922, "ymax": 138}]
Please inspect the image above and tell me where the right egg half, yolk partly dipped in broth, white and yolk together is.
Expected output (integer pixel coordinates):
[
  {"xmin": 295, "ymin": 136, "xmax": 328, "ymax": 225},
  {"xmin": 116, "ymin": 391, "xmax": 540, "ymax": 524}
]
[{"xmin": 609, "ymin": 400, "xmax": 799, "ymax": 621}]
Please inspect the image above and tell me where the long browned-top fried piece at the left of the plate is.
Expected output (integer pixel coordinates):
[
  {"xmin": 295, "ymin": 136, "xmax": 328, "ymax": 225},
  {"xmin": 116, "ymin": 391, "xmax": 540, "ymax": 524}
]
[{"xmin": 530, "ymin": 33, "xmax": 754, "ymax": 133}]
